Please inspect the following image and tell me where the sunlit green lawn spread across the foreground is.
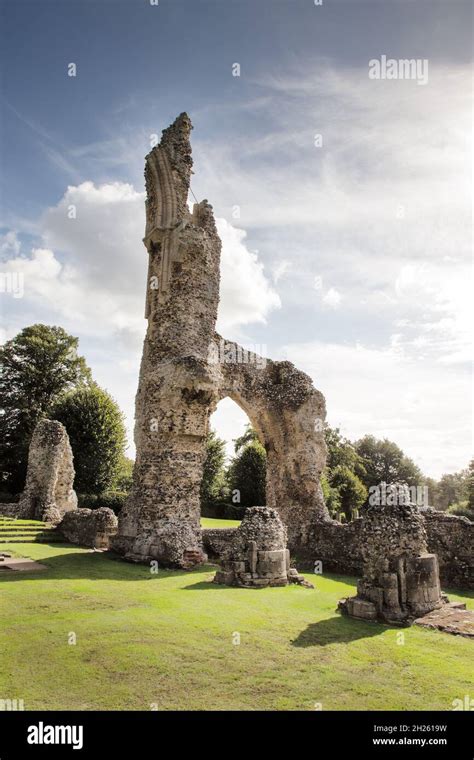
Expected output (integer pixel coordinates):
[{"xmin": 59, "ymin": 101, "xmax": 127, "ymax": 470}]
[{"xmin": 0, "ymin": 544, "xmax": 474, "ymax": 710}]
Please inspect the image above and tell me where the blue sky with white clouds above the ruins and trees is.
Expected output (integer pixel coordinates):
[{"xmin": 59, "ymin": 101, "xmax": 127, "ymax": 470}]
[{"xmin": 0, "ymin": 0, "xmax": 472, "ymax": 476}]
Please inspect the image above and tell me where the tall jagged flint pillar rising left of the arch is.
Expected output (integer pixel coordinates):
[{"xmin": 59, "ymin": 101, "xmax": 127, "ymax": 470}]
[{"xmin": 114, "ymin": 114, "xmax": 221, "ymax": 566}]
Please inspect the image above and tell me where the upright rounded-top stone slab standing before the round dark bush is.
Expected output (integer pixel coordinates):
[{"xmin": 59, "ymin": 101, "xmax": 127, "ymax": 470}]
[{"xmin": 17, "ymin": 419, "xmax": 77, "ymax": 524}]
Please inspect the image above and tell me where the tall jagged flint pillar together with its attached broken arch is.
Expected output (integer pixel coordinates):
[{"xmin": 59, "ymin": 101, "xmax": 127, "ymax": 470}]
[{"xmin": 114, "ymin": 113, "xmax": 328, "ymax": 567}]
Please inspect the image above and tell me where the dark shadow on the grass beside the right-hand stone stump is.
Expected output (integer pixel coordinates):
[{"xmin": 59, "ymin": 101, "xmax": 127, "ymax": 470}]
[{"xmin": 291, "ymin": 615, "xmax": 386, "ymax": 647}]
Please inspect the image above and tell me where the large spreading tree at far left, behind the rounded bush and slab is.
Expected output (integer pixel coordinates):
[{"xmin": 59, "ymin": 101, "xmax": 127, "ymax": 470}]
[{"xmin": 0, "ymin": 324, "xmax": 91, "ymax": 493}]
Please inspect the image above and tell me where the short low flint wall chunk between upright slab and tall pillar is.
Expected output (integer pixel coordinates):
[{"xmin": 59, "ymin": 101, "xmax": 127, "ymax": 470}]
[{"xmin": 58, "ymin": 507, "xmax": 118, "ymax": 549}]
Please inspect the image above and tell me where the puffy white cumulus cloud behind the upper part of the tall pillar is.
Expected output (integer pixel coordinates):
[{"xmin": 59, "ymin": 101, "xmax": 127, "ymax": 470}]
[{"xmin": 0, "ymin": 182, "xmax": 280, "ymax": 458}]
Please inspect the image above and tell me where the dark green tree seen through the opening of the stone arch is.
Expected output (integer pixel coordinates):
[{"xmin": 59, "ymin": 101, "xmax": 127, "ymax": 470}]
[{"xmin": 228, "ymin": 428, "xmax": 267, "ymax": 507}]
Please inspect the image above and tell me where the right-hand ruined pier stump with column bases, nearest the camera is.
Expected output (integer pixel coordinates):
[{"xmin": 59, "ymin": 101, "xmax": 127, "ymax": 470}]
[{"xmin": 339, "ymin": 484, "xmax": 448, "ymax": 624}]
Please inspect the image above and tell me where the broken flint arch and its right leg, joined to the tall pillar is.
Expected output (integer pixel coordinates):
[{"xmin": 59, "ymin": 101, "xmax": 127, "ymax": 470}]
[{"xmin": 209, "ymin": 335, "xmax": 329, "ymax": 549}]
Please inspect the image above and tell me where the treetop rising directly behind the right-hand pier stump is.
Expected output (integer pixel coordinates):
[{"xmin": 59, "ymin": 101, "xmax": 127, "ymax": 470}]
[{"xmin": 355, "ymin": 435, "xmax": 423, "ymax": 489}]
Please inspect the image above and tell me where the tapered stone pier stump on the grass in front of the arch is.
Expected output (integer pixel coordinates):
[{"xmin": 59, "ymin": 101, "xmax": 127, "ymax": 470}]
[{"xmin": 214, "ymin": 507, "xmax": 313, "ymax": 588}]
